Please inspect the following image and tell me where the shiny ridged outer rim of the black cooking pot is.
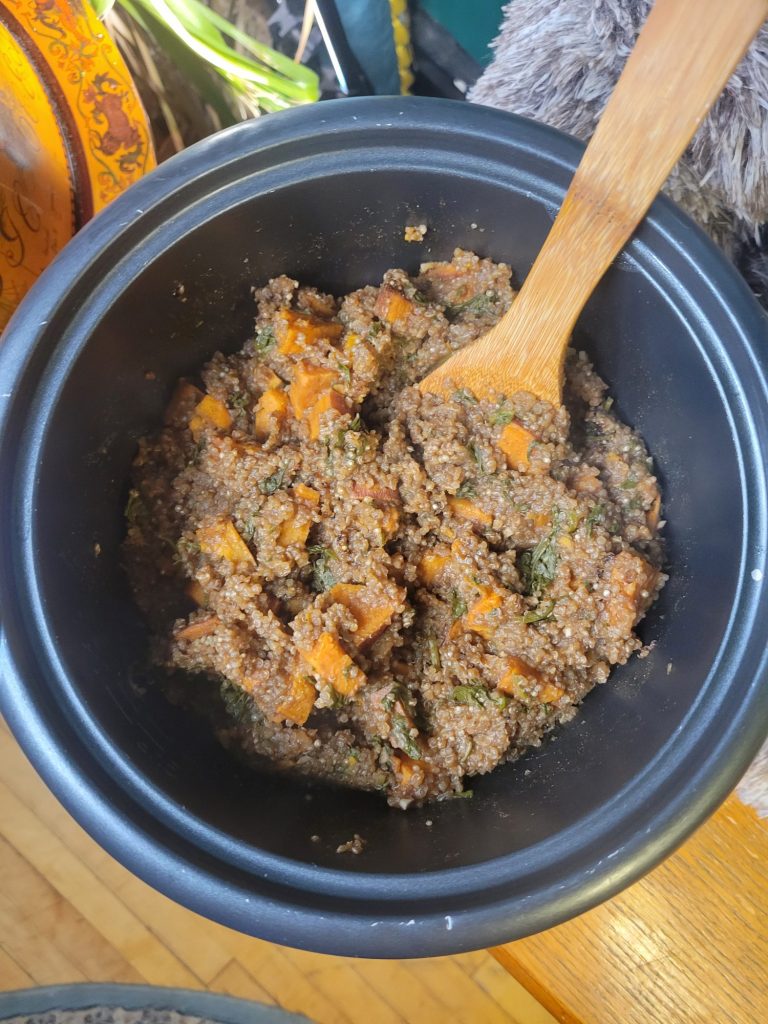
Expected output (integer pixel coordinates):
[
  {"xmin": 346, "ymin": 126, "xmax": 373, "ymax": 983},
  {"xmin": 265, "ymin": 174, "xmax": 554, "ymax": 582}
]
[{"xmin": 0, "ymin": 97, "xmax": 768, "ymax": 956}]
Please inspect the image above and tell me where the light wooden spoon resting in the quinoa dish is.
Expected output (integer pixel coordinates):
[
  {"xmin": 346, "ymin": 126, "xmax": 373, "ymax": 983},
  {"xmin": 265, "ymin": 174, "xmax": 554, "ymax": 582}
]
[{"xmin": 420, "ymin": 0, "xmax": 768, "ymax": 404}]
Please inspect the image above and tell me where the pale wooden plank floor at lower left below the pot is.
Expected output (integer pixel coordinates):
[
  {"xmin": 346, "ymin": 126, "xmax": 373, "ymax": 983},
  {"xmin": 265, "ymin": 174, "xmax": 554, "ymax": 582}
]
[{"xmin": 0, "ymin": 720, "xmax": 554, "ymax": 1024}]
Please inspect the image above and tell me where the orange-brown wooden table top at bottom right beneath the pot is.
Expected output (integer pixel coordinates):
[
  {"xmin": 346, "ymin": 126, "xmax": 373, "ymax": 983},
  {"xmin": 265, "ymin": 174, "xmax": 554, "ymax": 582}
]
[{"xmin": 492, "ymin": 796, "xmax": 768, "ymax": 1024}]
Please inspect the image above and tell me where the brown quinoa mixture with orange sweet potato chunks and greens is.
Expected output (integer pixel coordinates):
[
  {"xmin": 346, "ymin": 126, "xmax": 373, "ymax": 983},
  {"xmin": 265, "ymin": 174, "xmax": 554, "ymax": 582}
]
[{"xmin": 125, "ymin": 250, "xmax": 665, "ymax": 807}]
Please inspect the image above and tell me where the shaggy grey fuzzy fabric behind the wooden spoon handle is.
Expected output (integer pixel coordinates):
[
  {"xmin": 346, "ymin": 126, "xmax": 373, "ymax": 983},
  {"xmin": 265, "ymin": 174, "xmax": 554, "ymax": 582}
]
[{"xmin": 469, "ymin": 0, "xmax": 768, "ymax": 301}]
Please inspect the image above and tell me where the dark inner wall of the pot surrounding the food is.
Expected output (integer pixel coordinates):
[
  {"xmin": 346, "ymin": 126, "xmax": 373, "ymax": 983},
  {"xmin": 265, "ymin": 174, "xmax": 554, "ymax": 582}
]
[{"xmin": 27, "ymin": 167, "xmax": 742, "ymax": 873}]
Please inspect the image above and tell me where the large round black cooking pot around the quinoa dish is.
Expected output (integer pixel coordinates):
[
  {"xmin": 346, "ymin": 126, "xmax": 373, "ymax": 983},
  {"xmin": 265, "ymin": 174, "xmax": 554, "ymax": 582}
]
[{"xmin": 0, "ymin": 98, "xmax": 768, "ymax": 956}]
